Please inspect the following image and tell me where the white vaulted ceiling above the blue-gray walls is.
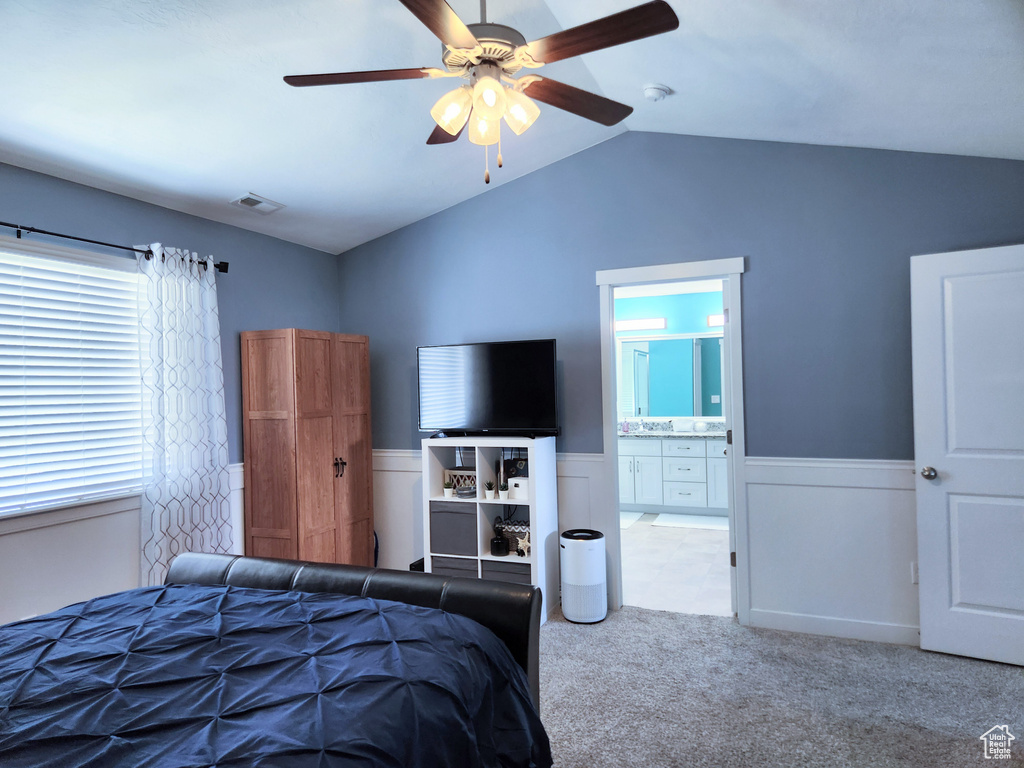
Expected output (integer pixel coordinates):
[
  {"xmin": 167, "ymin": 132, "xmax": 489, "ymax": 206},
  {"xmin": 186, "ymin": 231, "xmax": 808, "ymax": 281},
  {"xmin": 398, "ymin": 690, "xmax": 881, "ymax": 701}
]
[{"xmin": 0, "ymin": 0, "xmax": 1024, "ymax": 253}]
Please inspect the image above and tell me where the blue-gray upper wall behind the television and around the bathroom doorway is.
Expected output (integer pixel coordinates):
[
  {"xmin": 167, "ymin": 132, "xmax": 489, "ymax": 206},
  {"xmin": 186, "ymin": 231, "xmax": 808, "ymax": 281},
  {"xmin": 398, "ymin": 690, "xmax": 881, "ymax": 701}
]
[{"xmin": 339, "ymin": 132, "xmax": 1024, "ymax": 459}]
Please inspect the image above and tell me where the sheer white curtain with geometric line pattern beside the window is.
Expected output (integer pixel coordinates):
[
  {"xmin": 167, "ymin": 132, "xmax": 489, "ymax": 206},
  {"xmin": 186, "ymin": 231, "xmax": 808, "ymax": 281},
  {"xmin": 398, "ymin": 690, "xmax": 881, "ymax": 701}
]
[{"xmin": 138, "ymin": 243, "xmax": 231, "ymax": 586}]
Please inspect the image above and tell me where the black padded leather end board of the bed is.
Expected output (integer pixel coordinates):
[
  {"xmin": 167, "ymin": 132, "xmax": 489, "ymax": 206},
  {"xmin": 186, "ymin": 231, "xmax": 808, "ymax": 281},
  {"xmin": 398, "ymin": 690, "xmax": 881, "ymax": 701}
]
[{"xmin": 164, "ymin": 552, "xmax": 541, "ymax": 709}]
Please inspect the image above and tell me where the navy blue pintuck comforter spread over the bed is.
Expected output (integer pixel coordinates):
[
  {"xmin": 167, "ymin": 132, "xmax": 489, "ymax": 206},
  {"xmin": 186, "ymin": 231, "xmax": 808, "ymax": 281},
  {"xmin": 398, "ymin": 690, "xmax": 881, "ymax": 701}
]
[{"xmin": 0, "ymin": 585, "xmax": 551, "ymax": 768}]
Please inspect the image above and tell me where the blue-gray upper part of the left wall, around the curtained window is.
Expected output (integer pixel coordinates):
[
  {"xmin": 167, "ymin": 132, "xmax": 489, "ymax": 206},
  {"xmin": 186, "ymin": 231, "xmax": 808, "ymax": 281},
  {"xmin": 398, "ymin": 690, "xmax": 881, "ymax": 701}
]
[{"xmin": 0, "ymin": 164, "xmax": 339, "ymax": 462}]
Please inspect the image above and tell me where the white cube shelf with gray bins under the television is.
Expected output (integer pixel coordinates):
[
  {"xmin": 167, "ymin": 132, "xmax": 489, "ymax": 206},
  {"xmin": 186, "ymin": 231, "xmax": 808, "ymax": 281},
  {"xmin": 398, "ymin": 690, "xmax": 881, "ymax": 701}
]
[{"xmin": 422, "ymin": 437, "xmax": 559, "ymax": 621}]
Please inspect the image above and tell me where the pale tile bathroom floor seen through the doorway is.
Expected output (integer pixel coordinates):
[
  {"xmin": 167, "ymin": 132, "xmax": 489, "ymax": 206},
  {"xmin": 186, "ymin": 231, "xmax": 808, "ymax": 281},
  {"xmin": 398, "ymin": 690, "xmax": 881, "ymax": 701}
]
[{"xmin": 621, "ymin": 514, "xmax": 732, "ymax": 616}]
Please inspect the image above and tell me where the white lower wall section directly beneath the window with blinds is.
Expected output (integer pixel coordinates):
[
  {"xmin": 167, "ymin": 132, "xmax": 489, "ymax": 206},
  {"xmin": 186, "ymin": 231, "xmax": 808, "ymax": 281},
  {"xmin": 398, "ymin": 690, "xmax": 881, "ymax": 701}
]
[{"xmin": 0, "ymin": 497, "xmax": 140, "ymax": 624}]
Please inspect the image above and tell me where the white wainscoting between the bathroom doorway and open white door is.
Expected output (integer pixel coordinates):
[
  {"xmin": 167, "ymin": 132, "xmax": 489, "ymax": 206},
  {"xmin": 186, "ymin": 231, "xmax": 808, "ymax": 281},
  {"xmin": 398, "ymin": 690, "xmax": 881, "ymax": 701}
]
[{"xmin": 744, "ymin": 458, "xmax": 919, "ymax": 645}]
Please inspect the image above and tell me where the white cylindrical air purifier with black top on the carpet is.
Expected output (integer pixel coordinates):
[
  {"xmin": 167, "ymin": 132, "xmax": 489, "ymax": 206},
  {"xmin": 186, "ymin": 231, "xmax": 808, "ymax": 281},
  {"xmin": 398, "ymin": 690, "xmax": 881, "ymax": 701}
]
[{"xmin": 558, "ymin": 528, "xmax": 608, "ymax": 624}]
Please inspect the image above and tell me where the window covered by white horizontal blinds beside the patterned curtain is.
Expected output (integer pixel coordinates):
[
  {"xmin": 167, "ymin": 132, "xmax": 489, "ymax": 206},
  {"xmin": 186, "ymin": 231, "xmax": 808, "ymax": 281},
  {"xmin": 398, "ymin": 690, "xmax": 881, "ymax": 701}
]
[{"xmin": 0, "ymin": 238, "xmax": 142, "ymax": 515}]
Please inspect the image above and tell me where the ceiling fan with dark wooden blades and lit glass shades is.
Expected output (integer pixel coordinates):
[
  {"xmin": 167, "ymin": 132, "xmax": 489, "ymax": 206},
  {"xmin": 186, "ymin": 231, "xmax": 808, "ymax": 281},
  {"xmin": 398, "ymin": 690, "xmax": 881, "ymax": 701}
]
[{"xmin": 285, "ymin": 0, "xmax": 679, "ymax": 183}]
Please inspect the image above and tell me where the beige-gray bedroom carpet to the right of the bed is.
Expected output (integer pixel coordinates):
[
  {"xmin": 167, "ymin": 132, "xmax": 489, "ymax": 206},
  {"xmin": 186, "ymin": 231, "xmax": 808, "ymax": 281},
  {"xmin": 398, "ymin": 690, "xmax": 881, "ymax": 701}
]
[{"xmin": 541, "ymin": 607, "xmax": 1024, "ymax": 768}]
